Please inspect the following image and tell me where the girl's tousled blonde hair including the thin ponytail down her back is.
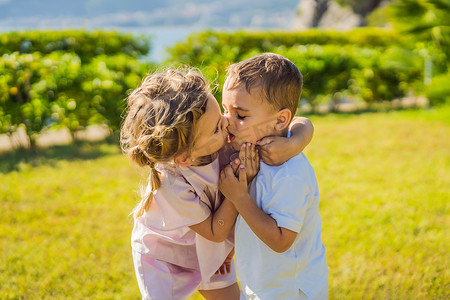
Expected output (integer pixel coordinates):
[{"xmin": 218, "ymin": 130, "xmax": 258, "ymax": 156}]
[{"xmin": 120, "ymin": 69, "xmax": 210, "ymax": 218}]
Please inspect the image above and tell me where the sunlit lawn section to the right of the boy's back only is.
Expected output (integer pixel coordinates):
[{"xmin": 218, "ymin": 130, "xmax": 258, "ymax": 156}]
[{"xmin": 306, "ymin": 109, "xmax": 450, "ymax": 299}]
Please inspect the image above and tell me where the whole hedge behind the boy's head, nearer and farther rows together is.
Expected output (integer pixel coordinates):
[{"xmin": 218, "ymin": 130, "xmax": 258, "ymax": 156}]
[{"xmin": 169, "ymin": 28, "xmax": 423, "ymax": 104}]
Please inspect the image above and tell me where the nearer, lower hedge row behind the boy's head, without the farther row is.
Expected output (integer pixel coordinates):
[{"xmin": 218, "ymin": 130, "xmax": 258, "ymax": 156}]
[{"xmin": 166, "ymin": 45, "xmax": 423, "ymax": 105}]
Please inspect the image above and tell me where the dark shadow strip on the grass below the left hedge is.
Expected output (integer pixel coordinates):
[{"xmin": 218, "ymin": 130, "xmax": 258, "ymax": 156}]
[{"xmin": 0, "ymin": 134, "xmax": 121, "ymax": 173}]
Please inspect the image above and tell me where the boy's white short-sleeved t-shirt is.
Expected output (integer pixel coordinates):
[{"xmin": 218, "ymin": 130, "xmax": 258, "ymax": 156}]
[{"xmin": 235, "ymin": 153, "xmax": 328, "ymax": 299}]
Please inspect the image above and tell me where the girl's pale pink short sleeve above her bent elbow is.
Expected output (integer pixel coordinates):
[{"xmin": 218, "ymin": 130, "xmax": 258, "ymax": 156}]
[{"xmin": 146, "ymin": 172, "xmax": 211, "ymax": 230}]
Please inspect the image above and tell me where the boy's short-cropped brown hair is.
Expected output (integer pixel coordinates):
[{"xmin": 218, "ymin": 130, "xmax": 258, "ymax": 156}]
[{"xmin": 225, "ymin": 53, "xmax": 303, "ymax": 117}]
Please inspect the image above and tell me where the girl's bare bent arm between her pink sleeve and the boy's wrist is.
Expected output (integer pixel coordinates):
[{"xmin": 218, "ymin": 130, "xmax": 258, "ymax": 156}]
[{"xmin": 189, "ymin": 199, "xmax": 238, "ymax": 243}]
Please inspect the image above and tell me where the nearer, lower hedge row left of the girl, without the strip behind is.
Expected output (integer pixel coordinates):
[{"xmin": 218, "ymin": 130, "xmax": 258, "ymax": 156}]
[{"xmin": 0, "ymin": 52, "xmax": 153, "ymax": 147}]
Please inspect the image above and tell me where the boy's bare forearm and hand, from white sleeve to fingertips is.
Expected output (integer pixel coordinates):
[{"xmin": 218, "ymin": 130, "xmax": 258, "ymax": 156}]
[{"xmin": 219, "ymin": 165, "xmax": 297, "ymax": 253}]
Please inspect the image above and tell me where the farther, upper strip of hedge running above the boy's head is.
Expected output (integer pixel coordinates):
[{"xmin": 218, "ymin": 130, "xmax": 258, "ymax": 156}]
[{"xmin": 169, "ymin": 28, "xmax": 401, "ymax": 66}]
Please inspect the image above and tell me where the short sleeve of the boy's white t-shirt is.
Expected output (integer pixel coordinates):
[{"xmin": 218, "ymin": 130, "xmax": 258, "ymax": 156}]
[{"xmin": 262, "ymin": 176, "xmax": 311, "ymax": 233}]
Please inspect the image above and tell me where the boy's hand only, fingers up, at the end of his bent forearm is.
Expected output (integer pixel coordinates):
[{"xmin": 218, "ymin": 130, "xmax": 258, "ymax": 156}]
[{"xmin": 219, "ymin": 164, "xmax": 247, "ymax": 204}]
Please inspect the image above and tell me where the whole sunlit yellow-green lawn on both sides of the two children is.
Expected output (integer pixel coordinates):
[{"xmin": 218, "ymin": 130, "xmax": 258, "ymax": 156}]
[{"xmin": 0, "ymin": 107, "xmax": 450, "ymax": 299}]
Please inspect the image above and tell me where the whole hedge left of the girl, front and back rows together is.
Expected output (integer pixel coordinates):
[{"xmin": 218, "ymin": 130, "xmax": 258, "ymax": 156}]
[{"xmin": 0, "ymin": 31, "xmax": 154, "ymax": 147}]
